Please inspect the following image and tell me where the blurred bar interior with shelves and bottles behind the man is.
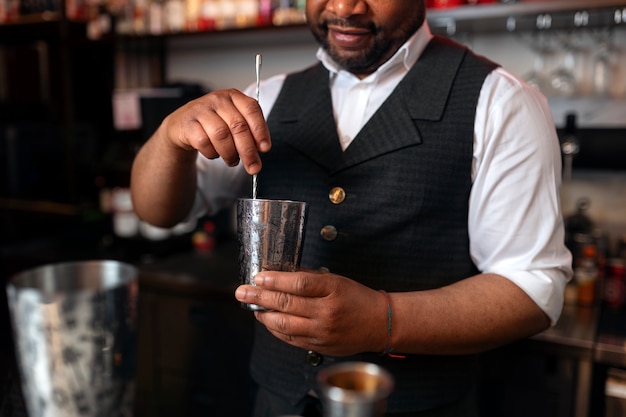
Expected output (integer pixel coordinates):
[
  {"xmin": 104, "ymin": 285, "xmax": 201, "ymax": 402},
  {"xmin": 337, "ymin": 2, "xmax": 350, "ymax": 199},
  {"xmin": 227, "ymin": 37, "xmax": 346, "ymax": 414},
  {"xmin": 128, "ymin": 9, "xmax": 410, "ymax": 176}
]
[{"xmin": 0, "ymin": 0, "xmax": 626, "ymax": 417}]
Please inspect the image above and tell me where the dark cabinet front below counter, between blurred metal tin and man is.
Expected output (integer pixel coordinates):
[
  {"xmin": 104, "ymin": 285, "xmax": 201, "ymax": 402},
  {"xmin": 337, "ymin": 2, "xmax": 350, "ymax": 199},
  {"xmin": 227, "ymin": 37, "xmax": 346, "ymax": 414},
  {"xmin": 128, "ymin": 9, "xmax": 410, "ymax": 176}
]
[{"xmin": 136, "ymin": 290, "xmax": 253, "ymax": 417}]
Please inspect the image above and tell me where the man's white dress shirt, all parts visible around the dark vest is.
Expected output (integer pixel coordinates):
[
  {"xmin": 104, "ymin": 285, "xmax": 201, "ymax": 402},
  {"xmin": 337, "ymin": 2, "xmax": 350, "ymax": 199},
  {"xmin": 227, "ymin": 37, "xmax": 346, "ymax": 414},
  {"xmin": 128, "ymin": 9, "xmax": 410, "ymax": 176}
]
[{"xmin": 192, "ymin": 23, "xmax": 572, "ymax": 325}]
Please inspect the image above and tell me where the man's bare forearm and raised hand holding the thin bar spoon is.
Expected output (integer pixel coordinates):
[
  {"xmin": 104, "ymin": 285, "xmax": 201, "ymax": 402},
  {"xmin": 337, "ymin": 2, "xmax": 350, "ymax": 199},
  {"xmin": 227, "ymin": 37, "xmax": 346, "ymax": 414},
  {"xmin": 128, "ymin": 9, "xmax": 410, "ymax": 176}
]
[{"xmin": 131, "ymin": 86, "xmax": 271, "ymax": 227}]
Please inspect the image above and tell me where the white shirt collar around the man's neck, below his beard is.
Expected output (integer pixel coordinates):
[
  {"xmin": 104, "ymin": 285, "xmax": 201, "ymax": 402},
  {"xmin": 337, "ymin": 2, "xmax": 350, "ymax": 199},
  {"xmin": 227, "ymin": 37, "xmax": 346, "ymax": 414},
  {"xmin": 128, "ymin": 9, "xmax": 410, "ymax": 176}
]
[{"xmin": 317, "ymin": 20, "xmax": 433, "ymax": 79}]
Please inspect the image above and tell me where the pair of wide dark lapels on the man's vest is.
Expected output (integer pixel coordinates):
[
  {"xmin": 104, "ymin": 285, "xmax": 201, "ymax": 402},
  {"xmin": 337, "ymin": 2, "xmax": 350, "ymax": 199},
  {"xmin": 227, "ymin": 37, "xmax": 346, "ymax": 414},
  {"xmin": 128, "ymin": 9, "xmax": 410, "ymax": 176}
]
[{"xmin": 272, "ymin": 37, "xmax": 466, "ymax": 174}]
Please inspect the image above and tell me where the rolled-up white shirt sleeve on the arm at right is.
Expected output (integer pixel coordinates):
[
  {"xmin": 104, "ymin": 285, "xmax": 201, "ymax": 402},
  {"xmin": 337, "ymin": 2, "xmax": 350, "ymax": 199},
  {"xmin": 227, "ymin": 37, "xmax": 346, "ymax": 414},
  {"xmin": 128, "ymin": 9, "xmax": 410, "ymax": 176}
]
[{"xmin": 468, "ymin": 69, "xmax": 572, "ymax": 325}]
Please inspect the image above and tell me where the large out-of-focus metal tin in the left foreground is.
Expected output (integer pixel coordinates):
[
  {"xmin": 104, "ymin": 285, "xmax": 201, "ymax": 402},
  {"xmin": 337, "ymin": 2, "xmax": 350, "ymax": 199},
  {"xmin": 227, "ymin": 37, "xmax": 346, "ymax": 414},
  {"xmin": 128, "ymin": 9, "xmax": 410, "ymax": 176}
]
[{"xmin": 7, "ymin": 261, "xmax": 137, "ymax": 417}]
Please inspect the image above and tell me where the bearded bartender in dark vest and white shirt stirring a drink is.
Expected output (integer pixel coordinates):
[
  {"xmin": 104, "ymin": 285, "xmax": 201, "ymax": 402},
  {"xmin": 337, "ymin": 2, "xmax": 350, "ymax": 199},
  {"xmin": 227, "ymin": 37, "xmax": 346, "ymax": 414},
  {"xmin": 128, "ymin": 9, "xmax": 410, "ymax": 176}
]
[{"xmin": 131, "ymin": 0, "xmax": 571, "ymax": 417}]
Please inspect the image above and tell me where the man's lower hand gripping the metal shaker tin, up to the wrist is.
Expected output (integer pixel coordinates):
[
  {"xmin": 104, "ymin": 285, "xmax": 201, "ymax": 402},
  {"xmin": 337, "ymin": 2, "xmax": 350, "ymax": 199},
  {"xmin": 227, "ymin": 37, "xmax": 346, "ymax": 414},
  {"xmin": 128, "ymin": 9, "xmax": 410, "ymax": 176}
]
[{"xmin": 235, "ymin": 271, "xmax": 387, "ymax": 356}]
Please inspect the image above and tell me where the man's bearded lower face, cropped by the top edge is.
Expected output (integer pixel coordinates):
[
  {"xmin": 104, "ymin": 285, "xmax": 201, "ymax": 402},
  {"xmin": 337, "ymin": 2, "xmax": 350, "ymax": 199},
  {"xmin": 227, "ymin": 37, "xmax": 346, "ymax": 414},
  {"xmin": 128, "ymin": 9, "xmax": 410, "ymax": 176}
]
[{"xmin": 306, "ymin": 0, "xmax": 425, "ymax": 78}]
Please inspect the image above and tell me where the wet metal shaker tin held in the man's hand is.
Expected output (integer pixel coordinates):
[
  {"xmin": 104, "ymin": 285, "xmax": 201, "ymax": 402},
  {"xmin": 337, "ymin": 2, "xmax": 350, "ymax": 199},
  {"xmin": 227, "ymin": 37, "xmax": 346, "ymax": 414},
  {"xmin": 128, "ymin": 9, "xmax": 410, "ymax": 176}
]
[{"xmin": 237, "ymin": 198, "xmax": 306, "ymax": 310}]
